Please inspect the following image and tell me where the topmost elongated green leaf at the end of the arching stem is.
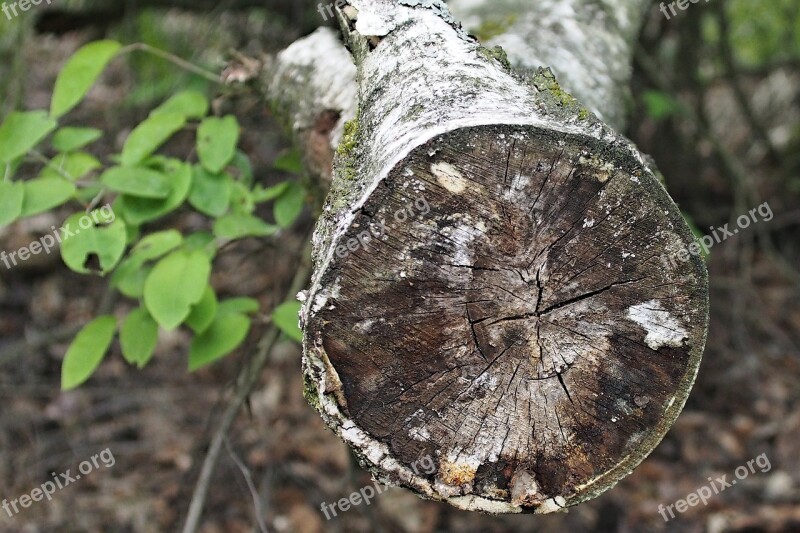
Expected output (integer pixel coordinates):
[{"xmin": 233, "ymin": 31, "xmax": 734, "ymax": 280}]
[{"xmin": 50, "ymin": 41, "xmax": 121, "ymax": 118}]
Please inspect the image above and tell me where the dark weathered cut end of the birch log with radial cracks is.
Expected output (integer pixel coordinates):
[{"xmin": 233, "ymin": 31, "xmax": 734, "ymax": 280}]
[{"xmin": 304, "ymin": 126, "xmax": 707, "ymax": 513}]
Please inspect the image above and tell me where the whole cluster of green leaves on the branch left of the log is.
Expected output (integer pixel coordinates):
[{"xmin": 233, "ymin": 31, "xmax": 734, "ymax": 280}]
[{"xmin": 0, "ymin": 41, "xmax": 307, "ymax": 390}]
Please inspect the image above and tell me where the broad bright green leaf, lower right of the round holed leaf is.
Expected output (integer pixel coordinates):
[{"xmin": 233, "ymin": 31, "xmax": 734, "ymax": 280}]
[{"xmin": 144, "ymin": 250, "xmax": 211, "ymax": 331}]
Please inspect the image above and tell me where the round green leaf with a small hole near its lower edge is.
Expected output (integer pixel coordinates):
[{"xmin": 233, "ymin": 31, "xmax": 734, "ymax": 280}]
[{"xmin": 61, "ymin": 209, "xmax": 128, "ymax": 274}]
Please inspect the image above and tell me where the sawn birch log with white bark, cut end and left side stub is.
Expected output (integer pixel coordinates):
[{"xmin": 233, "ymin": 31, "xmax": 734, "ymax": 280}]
[{"xmin": 270, "ymin": 0, "xmax": 708, "ymax": 513}]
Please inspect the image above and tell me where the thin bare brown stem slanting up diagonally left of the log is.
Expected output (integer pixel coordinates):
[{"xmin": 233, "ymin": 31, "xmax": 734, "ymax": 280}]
[{"xmin": 183, "ymin": 239, "xmax": 311, "ymax": 533}]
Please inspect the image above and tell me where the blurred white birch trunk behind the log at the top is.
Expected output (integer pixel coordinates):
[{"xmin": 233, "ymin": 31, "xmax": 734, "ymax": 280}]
[{"xmin": 448, "ymin": 0, "xmax": 652, "ymax": 129}]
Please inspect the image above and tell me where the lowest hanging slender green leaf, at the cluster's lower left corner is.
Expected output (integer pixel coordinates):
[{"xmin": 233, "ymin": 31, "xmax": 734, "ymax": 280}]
[{"xmin": 61, "ymin": 315, "xmax": 117, "ymax": 390}]
